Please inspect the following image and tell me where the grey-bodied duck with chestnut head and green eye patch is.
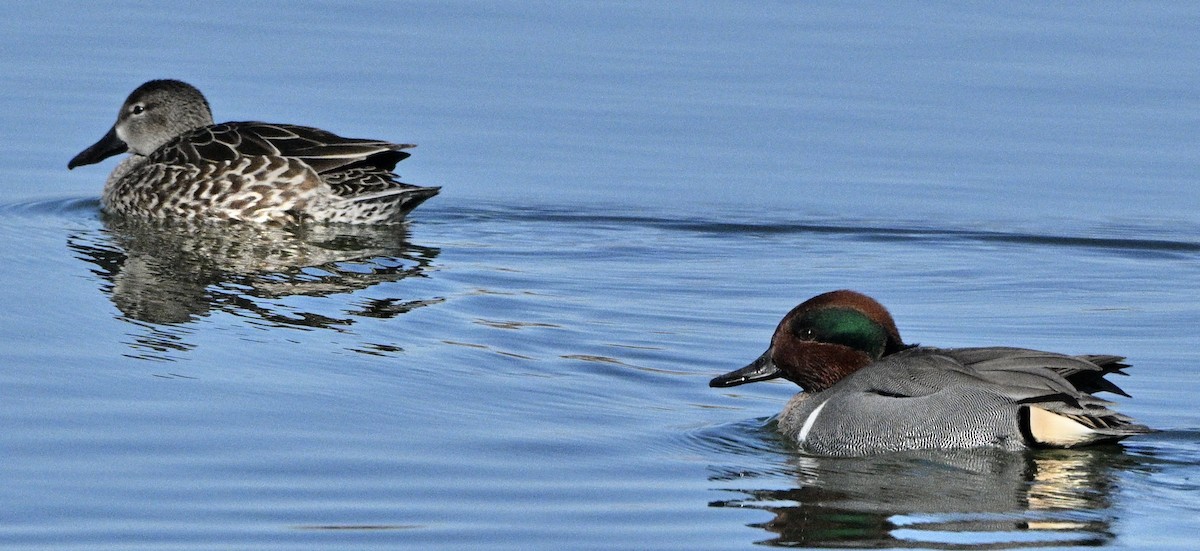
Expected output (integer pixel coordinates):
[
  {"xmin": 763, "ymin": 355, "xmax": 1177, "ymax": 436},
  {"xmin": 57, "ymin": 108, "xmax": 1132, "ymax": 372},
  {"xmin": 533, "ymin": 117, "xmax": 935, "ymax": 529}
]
[{"xmin": 709, "ymin": 289, "xmax": 1151, "ymax": 456}]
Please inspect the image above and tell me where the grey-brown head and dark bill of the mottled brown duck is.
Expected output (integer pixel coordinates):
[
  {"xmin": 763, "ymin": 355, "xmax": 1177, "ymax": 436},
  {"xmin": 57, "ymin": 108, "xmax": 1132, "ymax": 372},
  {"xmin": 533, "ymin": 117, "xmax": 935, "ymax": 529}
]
[{"xmin": 67, "ymin": 80, "xmax": 212, "ymax": 168}]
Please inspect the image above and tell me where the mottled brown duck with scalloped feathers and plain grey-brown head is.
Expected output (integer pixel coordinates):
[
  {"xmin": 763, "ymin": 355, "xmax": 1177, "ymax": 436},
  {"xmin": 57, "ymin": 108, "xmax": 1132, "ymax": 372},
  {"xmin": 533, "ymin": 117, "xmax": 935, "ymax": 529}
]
[{"xmin": 67, "ymin": 79, "xmax": 440, "ymax": 224}]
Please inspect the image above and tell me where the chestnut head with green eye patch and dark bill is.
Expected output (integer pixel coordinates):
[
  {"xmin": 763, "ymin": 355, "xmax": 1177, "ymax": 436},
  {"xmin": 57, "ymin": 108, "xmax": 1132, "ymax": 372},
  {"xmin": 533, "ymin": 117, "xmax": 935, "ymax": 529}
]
[{"xmin": 708, "ymin": 291, "xmax": 907, "ymax": 393}]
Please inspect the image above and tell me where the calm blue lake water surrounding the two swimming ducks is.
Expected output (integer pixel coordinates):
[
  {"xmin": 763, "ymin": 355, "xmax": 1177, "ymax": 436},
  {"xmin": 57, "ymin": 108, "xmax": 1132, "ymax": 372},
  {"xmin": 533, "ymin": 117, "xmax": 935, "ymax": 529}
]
[{"xmin": 0, "ymin": 1, "xmax": 1200, "ymax": 550}]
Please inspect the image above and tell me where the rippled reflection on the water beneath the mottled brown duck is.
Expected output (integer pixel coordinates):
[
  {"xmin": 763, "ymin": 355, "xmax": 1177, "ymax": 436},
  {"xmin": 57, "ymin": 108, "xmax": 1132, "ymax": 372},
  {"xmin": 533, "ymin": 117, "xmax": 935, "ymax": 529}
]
[{"xmin": 68, "ymin": 218, "xmax": 438, "ymax": 352}]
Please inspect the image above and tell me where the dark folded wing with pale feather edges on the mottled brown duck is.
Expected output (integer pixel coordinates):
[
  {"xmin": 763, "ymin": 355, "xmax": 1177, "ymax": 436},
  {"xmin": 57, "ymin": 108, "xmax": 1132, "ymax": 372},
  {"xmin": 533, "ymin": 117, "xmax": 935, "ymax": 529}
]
[{"xmin": 151, "ymin": 121, "xmax": 415, "ymax": 175}]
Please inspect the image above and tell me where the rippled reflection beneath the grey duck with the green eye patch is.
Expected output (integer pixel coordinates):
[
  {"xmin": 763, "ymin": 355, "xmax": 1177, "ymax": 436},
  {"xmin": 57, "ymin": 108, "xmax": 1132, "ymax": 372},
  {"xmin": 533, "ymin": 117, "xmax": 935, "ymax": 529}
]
[{"xmin": 712, "ymin": 448, "xmax": 1128, "ymax": 549}]
